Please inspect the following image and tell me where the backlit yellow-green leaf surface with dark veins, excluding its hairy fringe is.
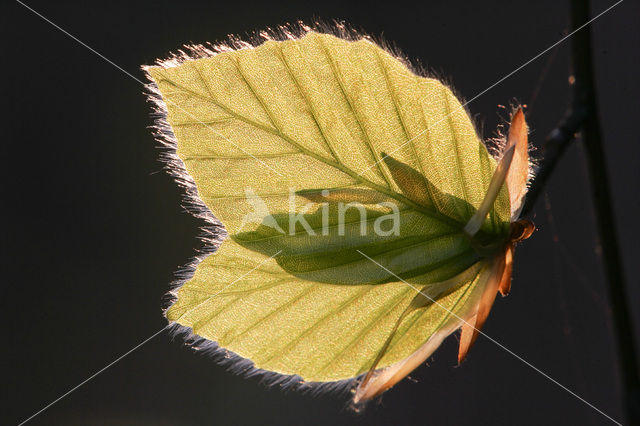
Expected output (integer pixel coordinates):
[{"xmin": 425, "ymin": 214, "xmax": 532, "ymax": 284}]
[{"xmin": 148, "ymin": 32, "xmax": 510, "ymax": 382}]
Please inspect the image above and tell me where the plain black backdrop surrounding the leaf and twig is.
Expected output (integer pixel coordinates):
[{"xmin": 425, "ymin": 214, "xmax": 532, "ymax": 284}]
[{"xmin": 0, "ymin": 0, "xmax": 640, "ymax": 425}]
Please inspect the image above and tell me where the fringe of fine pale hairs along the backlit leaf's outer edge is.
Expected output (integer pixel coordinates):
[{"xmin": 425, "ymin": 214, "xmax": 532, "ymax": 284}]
[{"xmin": 141, "ymin": 21, "xmax": 501, "ymax": 395}]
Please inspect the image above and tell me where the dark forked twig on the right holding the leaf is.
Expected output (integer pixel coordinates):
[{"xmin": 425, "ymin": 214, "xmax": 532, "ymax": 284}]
[{"xmin": 523, "ymin": 0, "xmax": 640, "ymax": 424}]
